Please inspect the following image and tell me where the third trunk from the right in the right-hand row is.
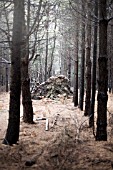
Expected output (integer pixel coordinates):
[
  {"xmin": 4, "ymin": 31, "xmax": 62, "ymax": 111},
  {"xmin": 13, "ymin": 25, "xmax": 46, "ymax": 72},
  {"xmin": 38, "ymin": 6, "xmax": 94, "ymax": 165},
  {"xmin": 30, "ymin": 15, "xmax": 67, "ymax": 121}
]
[{"xmin": 84, "ymin": 0, "xmax": 91, "ymax": 116}]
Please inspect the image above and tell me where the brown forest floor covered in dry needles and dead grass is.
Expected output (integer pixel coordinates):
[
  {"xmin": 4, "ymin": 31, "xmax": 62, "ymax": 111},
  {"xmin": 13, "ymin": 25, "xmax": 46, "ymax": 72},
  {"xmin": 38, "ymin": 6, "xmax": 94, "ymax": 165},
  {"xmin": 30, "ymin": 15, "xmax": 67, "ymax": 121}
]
[{"xmin": 0, "ymin": 92, "xmax": 113, "ymax": 170}]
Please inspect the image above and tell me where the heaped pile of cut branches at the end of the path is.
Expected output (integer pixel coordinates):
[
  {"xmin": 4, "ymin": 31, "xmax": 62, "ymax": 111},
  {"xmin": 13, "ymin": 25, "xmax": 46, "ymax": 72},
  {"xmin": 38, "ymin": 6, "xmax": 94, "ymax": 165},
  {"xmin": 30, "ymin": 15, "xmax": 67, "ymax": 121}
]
[{"xmin": 31, "ymin": 75, "xmax": 72, "ymax": 100}]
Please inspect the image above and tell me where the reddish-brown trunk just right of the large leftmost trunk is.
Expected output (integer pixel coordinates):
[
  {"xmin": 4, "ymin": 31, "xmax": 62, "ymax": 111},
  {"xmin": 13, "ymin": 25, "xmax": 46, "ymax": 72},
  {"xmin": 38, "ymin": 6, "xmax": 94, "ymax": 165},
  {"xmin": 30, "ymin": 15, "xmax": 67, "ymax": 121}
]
[{"xmin": 21, "ymin": 0, "xmax": 33, "ymax": 124}]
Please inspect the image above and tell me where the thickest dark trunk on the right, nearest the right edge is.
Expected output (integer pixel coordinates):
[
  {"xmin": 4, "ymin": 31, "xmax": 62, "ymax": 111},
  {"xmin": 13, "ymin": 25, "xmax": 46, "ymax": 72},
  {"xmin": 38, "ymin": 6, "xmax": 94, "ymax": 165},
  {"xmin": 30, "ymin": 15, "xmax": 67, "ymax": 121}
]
[{"xmin": 96, "ymin": 0, "xmax": 108, "ymax": 141}]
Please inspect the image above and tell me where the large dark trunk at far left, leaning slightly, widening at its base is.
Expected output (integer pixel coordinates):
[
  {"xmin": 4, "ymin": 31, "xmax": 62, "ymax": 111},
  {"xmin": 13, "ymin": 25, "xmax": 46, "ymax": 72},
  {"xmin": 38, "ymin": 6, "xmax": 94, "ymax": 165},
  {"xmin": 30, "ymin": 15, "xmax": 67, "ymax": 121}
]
[{"xmin": 3, "ymin": 0, "xmax": 22, "ymax": 145}]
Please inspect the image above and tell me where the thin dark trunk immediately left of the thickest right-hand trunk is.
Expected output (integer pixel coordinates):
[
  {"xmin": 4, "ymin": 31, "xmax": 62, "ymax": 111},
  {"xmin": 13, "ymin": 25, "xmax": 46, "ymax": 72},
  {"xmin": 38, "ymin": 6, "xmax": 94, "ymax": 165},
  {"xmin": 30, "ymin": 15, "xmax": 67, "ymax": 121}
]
[{"xmin": 89, "ymin": 0, "xmax": 98, "ymax": 127}]
